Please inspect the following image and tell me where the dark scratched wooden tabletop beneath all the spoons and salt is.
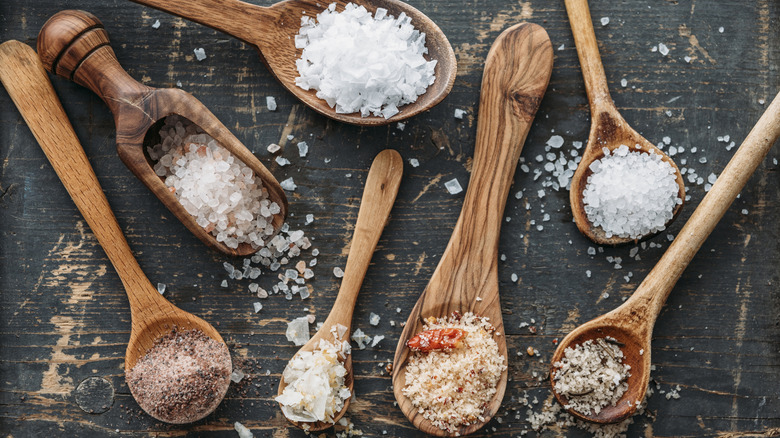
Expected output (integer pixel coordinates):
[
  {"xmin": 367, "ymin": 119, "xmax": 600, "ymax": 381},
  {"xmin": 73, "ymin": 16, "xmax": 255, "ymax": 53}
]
[{"xmin": 0, "ymin": 0, "xmax": 780, "ymax": 437}]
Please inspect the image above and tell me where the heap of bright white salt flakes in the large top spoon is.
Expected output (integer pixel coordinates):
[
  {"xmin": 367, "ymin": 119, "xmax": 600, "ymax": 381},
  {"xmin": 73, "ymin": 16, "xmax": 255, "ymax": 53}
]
[{"xmin": 295, "ymin": 3, "xmax": 436, "ymax": 119}]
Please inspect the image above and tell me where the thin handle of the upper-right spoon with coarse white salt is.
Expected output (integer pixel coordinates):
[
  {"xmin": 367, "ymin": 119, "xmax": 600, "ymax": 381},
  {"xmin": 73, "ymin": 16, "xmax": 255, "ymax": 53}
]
[{"xmin": 565, "ymin": 0, "xmax": 615, "ymax": 114}]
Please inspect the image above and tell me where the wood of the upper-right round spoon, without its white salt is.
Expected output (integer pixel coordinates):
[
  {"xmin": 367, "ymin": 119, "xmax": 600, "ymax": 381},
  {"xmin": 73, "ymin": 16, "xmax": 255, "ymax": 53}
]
[{"xmin": 565, "ymin": 0, "xmax": 685, "ymax": 245}]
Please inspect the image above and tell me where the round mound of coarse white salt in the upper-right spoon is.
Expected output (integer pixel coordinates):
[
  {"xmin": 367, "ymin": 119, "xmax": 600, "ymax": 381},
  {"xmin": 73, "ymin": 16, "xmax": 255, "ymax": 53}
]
[{"xmin": 583, "ymin": 145, "xmax": 682, "ymax": 239}]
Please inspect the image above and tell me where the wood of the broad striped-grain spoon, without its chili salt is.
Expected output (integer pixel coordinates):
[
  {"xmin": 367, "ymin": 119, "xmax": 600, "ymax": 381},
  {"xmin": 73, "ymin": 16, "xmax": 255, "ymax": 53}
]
[{"xmin": 393, "ymin": 23, "xmax": 553, "ymax": 436}]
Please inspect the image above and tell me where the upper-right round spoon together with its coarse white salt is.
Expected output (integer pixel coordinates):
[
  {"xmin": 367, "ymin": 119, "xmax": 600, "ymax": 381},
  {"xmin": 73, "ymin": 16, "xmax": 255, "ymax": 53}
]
[{"xmin": 565, "ymin": 0, "xmax": 685, "ymax": 245}]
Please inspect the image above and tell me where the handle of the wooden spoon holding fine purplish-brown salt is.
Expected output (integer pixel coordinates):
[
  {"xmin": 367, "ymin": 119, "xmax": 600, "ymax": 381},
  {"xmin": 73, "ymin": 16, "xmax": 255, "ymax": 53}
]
[{"xmin": 0, "ymin": 41, "xmax": 167, "ymax": 309}]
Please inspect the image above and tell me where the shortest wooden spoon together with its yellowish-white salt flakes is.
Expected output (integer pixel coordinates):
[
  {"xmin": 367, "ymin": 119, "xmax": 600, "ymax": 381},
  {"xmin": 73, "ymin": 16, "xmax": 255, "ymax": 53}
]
[{"xmin": 276, "ymin": 149, "xmax": 403, "ymax": 432}]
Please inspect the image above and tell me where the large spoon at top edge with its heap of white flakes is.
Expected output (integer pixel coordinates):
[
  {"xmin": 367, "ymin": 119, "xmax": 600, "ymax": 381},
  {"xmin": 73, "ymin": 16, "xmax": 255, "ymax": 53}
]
[{"xmin": 132, "ymin": 0, "xmax": 457, "ymax": 126}]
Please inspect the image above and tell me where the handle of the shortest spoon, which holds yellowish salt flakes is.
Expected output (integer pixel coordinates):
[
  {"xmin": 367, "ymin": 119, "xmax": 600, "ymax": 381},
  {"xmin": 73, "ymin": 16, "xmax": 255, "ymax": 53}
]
[{"xmin": 325, "ymin": 149, "xmax": 404, "ymax": 327}]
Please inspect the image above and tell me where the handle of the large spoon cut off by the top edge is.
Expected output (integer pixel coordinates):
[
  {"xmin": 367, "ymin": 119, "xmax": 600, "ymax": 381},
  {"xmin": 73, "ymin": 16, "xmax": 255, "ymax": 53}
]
[{"xmin": 131, "ymin": 0, "xmax": 268, "ymax": 46}]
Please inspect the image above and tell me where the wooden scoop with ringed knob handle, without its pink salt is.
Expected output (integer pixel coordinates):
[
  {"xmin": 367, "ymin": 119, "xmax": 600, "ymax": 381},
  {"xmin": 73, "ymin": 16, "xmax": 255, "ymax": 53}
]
[{"xmin": 38, "ymin": 10, "xmax": 287, "ymax": 256}]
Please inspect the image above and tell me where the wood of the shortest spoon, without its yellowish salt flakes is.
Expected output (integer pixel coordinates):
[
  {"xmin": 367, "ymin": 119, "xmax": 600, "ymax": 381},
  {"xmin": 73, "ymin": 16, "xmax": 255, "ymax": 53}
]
[{"xmin": 278, "ymin": 149, "xmax": 404, "ymax": 432}]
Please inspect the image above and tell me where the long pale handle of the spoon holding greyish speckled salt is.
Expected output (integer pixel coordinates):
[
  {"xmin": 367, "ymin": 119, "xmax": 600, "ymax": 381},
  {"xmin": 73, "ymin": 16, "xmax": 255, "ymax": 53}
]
[{"xmin": 632, "ymin": 93, "xmax": 780, "ymax": 323}]
